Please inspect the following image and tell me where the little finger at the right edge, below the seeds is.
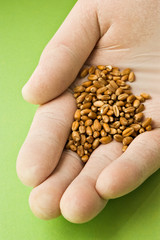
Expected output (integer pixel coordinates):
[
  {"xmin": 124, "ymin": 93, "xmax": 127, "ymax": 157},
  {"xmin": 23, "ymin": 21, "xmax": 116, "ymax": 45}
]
[{"xmin": 96, "ymin": 128, "xmax": 160, "ymax": 199}]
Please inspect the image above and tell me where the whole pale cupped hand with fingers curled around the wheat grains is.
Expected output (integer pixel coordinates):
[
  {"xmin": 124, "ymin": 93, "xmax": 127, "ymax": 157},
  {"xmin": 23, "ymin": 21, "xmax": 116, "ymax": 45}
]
[{"xmin": 17, "ymin": 0, "xmax": 160, "ymax": 223}]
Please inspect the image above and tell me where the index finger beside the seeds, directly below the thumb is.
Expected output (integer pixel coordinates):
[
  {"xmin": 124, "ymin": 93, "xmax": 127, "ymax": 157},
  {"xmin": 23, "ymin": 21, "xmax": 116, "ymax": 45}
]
[{"xmin": 17, "ymin": 92, "xmax": 75, "ymax": 186}]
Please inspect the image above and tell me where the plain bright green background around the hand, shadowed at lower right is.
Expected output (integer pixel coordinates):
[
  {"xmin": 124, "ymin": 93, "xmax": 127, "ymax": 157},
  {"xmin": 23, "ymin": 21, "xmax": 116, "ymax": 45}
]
[{"xmin": 0, "ymin": 0, "xmax": 160, "ymax": 240}]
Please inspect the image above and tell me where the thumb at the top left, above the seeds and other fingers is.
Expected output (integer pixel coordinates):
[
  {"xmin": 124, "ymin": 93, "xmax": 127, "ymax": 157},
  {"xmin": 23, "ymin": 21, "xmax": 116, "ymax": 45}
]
[{"xmin": 22, "ymin": 0, "xmax": 100, "ymax": 104}]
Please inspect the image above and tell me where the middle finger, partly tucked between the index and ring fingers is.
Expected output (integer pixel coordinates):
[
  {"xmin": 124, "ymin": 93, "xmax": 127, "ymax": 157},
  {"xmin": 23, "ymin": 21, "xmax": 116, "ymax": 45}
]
[{"xmin": 29, "ymin": 150, "xmax": 83, "ymax": 220}]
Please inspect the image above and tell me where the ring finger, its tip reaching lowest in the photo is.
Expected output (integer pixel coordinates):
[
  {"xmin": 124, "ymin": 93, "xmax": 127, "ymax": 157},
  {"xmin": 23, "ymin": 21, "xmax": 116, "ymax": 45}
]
[{"xmin": 60, "ymin": 142, "xmax": 121, "ymax": 223}]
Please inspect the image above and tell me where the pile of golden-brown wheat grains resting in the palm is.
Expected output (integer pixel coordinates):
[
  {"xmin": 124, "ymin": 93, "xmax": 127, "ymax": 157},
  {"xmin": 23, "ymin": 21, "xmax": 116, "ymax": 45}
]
[{"xmin": 66, "ymin": 65, "xmax": 152, "ymax": 162}]
